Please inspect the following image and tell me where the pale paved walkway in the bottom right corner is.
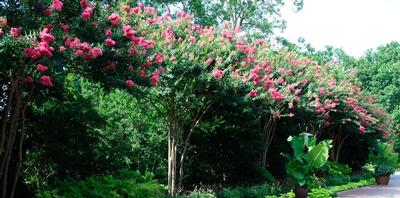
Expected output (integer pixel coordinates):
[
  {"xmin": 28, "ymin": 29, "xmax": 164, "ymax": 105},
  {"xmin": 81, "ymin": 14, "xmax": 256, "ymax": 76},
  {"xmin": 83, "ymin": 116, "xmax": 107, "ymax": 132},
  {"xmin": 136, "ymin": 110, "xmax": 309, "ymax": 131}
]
[{"xmin": 338, "ymin": 172, "xmax": 400, "ymax": 198}]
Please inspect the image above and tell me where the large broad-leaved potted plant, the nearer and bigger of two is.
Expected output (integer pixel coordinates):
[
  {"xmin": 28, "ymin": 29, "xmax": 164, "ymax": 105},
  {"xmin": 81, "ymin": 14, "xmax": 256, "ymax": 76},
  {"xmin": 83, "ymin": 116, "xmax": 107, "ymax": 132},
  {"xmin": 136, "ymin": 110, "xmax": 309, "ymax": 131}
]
[{"xmin": 283, "ymin": 133, "xmax": 332, "ymax": 198}]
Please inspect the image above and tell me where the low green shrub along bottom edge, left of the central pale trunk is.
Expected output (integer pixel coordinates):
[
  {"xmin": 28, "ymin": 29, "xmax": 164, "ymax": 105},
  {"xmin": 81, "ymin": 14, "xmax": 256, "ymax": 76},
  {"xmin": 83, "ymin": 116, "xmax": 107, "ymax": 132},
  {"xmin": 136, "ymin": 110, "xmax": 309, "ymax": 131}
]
[{"xmin": 36, "ymin": 170, "xmax": 165, "ymax": 198}]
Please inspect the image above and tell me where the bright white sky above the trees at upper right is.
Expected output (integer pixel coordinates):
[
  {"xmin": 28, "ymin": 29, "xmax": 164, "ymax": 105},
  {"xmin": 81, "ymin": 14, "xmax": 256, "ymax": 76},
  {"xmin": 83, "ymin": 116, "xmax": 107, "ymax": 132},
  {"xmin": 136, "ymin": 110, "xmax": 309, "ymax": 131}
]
[{"xmin": 278, "ymin": 0, "xmax": 400, "ymax": 57}]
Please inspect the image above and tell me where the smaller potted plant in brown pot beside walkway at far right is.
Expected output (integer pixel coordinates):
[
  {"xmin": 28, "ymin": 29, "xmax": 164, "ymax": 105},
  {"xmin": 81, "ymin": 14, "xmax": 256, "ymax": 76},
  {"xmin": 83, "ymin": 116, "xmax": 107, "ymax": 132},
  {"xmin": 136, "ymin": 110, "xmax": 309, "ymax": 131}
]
[{"xmin": 370, "ymin": 142, "xmax": 399, "ymax": 185}]
